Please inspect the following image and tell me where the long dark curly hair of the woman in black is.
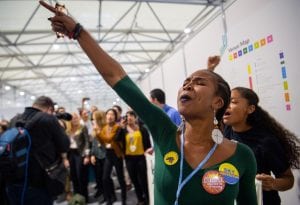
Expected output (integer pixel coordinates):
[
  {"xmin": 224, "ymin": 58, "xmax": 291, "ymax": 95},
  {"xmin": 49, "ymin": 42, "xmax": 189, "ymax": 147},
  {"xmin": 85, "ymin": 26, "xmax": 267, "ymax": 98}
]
[{"xmin": 232, "ymin": 87, "xmax": 300, "ymax": 168}]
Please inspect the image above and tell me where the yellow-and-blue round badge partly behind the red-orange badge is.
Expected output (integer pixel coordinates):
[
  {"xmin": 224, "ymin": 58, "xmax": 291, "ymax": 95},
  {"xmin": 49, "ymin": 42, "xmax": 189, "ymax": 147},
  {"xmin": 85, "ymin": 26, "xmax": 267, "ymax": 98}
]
[{"xmin": 219, "ymin": 163, "xmax": 240, "ymax": 184}]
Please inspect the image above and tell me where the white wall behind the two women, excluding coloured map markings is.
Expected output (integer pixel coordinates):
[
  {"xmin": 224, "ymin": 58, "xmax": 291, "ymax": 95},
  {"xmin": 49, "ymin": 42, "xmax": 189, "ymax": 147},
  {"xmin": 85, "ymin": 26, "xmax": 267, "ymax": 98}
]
[{"xmin": 140, "ymin": 0, "xmax": 300, "ymax": 205}]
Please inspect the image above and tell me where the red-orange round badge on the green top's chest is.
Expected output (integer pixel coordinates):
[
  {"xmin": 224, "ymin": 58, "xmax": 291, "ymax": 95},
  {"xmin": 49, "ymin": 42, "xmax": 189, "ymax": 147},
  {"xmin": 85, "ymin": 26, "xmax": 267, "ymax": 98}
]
[{"xmin": 202, "ymin": 170, "xmax": 225, "ymax": 194}]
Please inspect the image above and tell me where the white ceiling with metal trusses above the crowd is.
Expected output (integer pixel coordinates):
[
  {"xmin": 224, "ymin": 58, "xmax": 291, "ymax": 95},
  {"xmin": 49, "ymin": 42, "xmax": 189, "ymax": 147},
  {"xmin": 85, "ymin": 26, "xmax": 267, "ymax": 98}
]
[{"xmin": 0, "ymin": 0, "xmax": 229, "ymax": 109}]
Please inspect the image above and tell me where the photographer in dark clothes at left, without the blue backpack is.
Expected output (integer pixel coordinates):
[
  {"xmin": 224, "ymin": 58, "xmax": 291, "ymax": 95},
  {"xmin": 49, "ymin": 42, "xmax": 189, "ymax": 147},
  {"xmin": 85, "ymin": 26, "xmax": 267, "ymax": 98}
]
[{"xmin": 6, "ymin": 96, "xmax": 70, "ymax": 205}]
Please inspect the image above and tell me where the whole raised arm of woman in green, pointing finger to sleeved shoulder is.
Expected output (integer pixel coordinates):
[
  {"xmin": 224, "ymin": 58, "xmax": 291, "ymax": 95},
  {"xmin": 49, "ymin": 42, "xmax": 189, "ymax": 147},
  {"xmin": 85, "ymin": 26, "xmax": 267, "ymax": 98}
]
[{"xmin": 40, "ymin": 1, "xmax": 177, "ymax": 142}]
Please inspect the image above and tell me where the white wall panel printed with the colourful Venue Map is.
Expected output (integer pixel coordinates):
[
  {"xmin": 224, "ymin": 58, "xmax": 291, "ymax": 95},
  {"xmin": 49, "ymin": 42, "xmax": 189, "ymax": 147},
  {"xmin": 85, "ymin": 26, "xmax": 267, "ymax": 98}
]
[{"xmin": 220, "ymin": 0, "xmax": 300, "ymax": 136}]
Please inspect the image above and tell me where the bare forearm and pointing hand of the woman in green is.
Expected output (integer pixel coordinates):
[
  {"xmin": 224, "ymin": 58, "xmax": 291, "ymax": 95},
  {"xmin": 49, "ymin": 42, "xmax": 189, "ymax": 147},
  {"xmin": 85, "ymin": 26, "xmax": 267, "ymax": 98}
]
[{"xmin": 40, "ymin": 1, "xmax": 126, "ymax": 86}]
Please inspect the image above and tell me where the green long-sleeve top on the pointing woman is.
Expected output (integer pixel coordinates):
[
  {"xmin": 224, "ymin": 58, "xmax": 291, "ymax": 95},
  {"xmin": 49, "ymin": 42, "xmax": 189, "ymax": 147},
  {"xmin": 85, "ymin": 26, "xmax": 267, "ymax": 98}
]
[{"xmin": 113, "ymin": 76, "xmax": 257, "ymax": 205}]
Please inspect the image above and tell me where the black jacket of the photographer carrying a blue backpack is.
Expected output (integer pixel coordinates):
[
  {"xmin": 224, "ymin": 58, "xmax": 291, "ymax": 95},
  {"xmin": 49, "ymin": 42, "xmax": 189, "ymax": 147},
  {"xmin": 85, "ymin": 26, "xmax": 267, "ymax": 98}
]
[{"xmin": 11, "ymin": 107, "xmax": 70, "ymax": 188}]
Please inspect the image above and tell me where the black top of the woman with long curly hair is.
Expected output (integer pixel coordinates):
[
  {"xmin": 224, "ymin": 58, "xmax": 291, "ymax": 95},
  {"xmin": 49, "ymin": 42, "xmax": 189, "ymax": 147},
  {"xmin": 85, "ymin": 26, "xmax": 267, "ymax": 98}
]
[{"xmin": 224, "ymin": 126, "xmax": 290, "ymax": 205}]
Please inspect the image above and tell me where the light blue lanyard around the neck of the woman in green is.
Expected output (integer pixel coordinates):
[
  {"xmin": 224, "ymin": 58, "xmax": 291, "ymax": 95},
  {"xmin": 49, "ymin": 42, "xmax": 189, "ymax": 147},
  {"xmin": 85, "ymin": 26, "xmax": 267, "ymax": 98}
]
[{"xmin": 174, "ymin": 126, "xmax": 217, "ymax": 205}]
